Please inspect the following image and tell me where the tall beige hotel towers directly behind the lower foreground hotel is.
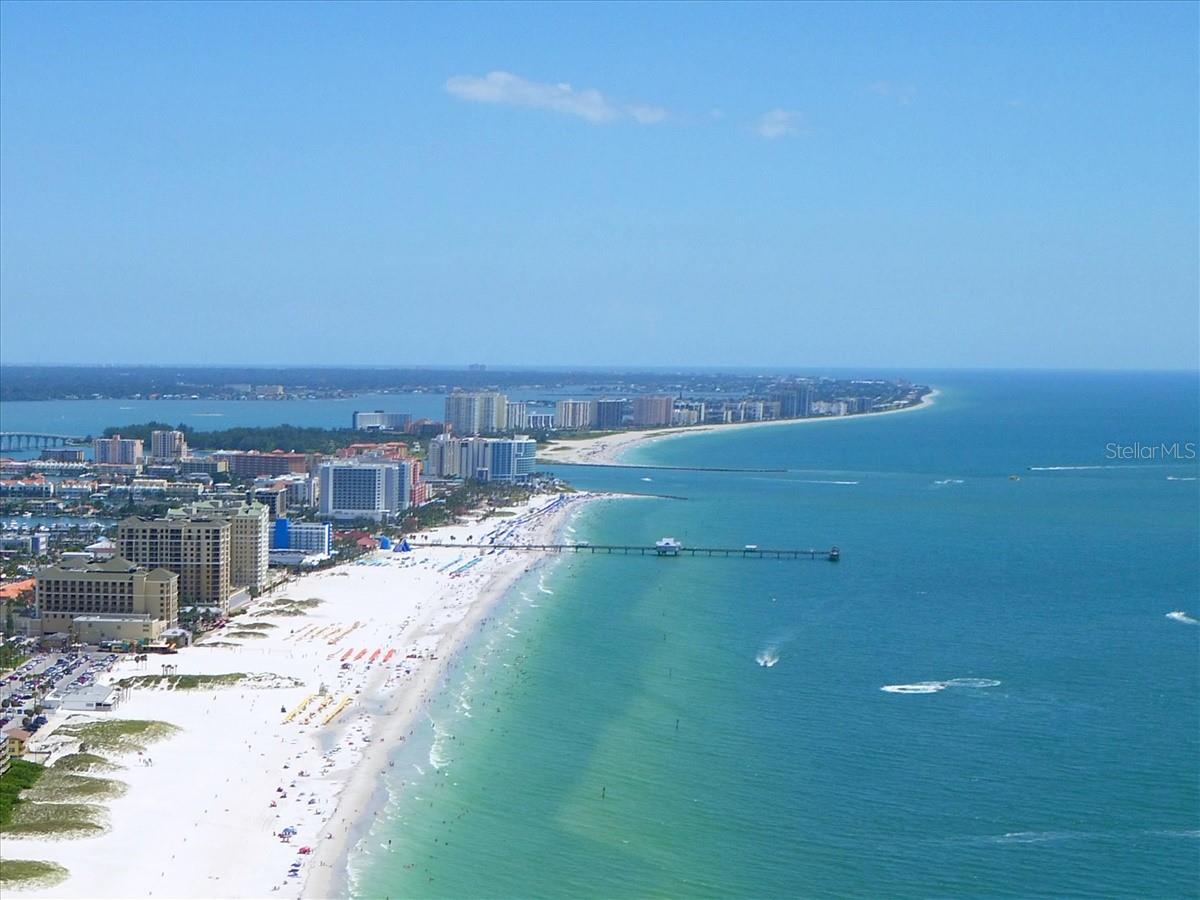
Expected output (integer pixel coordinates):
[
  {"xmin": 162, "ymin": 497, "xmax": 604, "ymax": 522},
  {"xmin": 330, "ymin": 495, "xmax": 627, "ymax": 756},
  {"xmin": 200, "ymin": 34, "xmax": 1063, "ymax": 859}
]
[{"xmin": 116, "ymin": 515, "xmax": 233, "ymax": 614}]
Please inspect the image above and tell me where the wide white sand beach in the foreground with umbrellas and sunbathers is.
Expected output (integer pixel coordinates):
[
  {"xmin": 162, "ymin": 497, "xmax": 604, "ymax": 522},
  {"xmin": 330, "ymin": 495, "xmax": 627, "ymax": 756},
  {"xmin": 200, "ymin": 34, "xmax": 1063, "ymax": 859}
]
[{"xmin": 4, "ymin": 493, "xmax": 596, "ymax": 898}]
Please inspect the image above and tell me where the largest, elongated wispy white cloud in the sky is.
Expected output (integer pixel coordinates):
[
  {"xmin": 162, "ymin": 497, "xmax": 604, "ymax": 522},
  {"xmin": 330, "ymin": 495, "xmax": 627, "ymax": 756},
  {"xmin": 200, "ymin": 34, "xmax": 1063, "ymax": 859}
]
[{"xmin": 445, "ymin": 72, "xmax": 667, "ymax": 125}]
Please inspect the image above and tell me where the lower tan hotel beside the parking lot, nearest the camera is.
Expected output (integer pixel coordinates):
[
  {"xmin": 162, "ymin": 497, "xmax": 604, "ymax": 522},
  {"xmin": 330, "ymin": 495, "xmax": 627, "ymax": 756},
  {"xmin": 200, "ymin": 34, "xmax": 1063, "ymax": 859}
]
[{"xmin": 34, "ymin": 557, "xmax": 179, "ymax": 643}]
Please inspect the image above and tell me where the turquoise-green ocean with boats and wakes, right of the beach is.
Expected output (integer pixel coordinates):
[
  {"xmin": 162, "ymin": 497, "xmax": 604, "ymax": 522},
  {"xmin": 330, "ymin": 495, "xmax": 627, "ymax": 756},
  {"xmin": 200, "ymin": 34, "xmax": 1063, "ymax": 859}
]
[{"xmin": 348, "ymin": 372, "xmax": 1200, "ymax": 898}]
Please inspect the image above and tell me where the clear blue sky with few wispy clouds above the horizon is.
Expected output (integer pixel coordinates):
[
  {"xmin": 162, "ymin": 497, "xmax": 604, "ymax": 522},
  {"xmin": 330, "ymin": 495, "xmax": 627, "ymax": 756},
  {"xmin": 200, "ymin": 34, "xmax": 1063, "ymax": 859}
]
[{"xmin": 0, "ymin": 0, "xmax": 1200, "ymax": 368}]
